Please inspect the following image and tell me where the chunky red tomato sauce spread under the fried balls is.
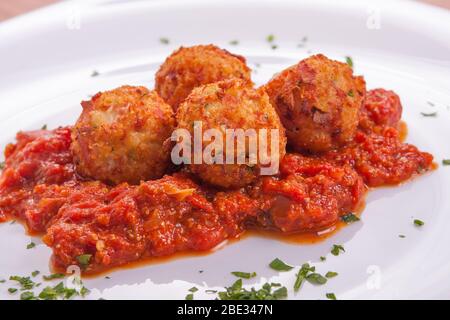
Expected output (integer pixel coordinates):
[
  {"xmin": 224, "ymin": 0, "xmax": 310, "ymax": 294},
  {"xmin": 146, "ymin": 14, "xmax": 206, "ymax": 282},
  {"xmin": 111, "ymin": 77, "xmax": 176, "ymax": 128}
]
[{"xmin": 0, "ymin": 89, "xmax": 433, "ymax": 273}]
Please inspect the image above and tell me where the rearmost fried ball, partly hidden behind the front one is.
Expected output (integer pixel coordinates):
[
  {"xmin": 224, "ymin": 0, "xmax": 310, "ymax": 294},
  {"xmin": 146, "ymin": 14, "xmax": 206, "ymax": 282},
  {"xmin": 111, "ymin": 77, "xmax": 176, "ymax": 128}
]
[{"xmin": 155, "ymin": 45, "xmax": 250, "ymax": 111}]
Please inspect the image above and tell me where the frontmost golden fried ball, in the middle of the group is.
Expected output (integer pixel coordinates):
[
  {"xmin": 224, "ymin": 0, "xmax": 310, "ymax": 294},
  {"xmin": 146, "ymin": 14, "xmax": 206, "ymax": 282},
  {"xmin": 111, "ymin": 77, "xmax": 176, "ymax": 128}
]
[{"xmin": 176, "ymin": 79, "xmax": 286, "ymax": 188}]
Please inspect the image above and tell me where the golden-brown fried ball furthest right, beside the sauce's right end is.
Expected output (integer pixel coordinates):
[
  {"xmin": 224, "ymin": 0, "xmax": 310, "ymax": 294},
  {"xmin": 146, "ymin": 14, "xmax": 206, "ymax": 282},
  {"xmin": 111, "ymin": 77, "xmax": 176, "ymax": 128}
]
[{"xmin": 265, "ymin": 54, "xmax": 366, "ymax": 153}]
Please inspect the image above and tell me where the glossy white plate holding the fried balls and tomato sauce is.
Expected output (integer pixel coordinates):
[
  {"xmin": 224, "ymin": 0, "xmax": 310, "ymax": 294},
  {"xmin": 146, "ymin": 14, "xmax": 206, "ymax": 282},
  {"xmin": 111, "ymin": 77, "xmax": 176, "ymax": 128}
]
[{"xmin": 0, "ymin": 0, "xmax": 450, "ymax": 299}]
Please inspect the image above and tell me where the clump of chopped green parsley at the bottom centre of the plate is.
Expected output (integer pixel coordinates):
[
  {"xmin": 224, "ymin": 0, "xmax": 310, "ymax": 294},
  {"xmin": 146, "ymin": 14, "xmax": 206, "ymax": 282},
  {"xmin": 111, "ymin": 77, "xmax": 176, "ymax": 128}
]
[{"xmin": 218, "ymin": 279, "xmax": 287, "ymax": 300}]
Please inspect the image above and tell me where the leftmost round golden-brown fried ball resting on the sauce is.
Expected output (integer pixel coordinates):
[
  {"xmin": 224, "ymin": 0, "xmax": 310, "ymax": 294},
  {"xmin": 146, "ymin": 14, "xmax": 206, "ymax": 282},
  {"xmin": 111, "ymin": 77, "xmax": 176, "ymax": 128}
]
[{"xmin": 71, "ymin": 86, "xmax": 175, "ymax": 184}]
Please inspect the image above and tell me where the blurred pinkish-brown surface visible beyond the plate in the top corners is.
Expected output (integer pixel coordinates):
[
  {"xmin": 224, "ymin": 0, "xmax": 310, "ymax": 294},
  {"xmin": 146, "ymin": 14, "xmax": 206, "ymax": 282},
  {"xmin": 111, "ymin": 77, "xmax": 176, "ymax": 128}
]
[{"xmin": 0, "ymin": 0, "xmax": 450, "ymax": 21}]
